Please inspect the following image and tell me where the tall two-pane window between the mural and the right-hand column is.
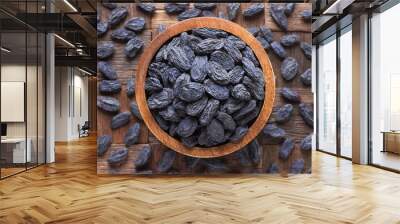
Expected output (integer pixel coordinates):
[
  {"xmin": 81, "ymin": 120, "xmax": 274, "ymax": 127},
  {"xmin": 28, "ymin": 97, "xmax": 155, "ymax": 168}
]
[{"xmin": 317, "ymin": 25, "xmax": 352, "ymax": 159}]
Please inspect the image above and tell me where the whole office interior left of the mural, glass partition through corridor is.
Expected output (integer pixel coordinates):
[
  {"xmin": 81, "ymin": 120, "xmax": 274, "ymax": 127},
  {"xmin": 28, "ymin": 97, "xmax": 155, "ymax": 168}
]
[{"xmin": 0, "ymin": 0, "xmax": 97, "ymax": 179}]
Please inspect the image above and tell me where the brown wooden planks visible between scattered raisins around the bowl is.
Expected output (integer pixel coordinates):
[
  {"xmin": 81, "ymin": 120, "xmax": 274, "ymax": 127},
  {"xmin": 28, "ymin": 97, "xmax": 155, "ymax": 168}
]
[{"xmin": 98, "ymin": 3, "xmax": 313, "ymax": 175}]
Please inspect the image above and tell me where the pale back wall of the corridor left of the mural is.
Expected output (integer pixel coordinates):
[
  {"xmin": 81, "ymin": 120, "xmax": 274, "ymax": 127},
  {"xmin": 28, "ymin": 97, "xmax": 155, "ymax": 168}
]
[{"xmin": 55, "ymin": 67, "xmax": 88, "ymax": 141}]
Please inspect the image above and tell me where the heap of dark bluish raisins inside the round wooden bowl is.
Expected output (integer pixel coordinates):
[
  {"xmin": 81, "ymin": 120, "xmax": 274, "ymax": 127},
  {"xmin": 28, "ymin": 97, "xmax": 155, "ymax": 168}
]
[{"xmin": 145, "ymin": 28, "xmax": 265, "ymax": 147}]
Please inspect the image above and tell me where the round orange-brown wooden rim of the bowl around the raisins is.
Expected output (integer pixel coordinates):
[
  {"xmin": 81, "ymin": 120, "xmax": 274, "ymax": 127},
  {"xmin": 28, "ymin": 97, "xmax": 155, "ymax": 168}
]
[{"xmin": 136, "ymin": 17, "xmax": 275, "ymax": 158}]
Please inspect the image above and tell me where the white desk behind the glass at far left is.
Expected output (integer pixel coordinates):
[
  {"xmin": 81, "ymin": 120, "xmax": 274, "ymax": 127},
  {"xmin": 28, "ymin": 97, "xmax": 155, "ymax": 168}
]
[{"xmin": 1, "ymin": 138, "xmax": 32, "ymax": 163}]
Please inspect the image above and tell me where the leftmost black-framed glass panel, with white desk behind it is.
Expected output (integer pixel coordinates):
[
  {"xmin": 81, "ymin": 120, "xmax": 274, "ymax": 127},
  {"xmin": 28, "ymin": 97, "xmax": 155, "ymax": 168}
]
[{"xmin": 0, "ymin": 31, "xmax": 27, "ymax": 177}]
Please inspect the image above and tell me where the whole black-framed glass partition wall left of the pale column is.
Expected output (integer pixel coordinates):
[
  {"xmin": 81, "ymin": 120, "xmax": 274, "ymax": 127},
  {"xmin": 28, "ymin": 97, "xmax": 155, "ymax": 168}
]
[{"xmin": 0, "ymin": 1, "xmax": 46, "ymax": 179}]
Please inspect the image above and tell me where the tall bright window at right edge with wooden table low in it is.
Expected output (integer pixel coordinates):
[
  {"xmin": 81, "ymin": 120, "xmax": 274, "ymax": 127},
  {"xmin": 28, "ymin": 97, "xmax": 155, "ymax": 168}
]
[{"xmin": 370, "ymin": 4, "xmax": 400, "ymax": 170}]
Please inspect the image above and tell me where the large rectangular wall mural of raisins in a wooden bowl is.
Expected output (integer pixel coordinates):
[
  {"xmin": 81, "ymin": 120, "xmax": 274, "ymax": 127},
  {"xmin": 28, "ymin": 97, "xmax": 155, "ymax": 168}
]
[{"xmin": 97, "ymin": 3, "xmax": 313, "ymax": 175}]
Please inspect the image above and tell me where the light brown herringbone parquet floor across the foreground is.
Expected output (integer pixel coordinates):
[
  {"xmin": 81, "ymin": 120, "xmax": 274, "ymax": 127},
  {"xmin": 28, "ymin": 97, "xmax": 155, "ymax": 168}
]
[{"xmin": 0, "ymin": 138, "xmax": 400, "ymax": 224}]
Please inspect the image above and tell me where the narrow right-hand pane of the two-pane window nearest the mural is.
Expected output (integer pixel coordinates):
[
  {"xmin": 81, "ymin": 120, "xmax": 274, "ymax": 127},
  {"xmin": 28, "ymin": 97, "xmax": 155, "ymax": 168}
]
[{"xmin": 339, "ymin": 27, "xmax": 353, "ymax": 158}]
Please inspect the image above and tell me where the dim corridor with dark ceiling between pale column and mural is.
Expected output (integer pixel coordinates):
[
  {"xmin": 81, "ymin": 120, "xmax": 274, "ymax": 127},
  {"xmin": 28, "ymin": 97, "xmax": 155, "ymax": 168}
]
[{"xmin": 53, "ymin": 1, "xmax": 97, "ymax": 145}]
